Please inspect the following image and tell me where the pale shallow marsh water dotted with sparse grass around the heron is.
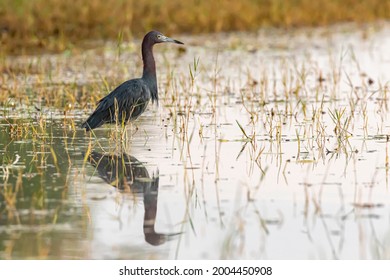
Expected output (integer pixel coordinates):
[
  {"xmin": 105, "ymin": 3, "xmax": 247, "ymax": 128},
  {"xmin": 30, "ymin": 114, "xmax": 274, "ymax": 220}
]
[{"xmin": 0, "ymin": 23, "xmax": 390, "ymax": 259}]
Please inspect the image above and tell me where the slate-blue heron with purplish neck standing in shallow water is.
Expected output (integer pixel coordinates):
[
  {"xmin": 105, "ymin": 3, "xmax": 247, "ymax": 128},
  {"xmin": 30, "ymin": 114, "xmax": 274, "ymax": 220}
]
[{"xmin": 81, "ymin": 31, "xmax": 183, "ymax": 131}]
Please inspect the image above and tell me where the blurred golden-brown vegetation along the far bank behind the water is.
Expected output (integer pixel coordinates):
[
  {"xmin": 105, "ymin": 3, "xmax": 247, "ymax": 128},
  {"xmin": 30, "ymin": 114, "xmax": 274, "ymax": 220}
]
[{"xmin": 0, "ymin": 0, "xmax": 390, "ymax": 53}]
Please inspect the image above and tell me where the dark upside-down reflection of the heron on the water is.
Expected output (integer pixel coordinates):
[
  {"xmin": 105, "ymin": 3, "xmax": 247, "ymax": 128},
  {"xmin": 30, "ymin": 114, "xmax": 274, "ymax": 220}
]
[{"xmin": 88, "ymin": 151, "xmax": 180, "ymax": 245}]
